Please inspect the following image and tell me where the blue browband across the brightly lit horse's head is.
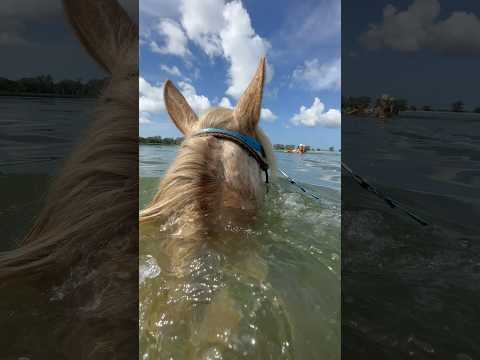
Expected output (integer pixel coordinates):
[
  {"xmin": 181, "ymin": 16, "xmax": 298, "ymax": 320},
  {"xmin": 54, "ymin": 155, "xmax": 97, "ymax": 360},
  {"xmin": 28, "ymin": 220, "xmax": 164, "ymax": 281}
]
[{"xmin": 192, "ymin": 128, "xmax": 268, "ymax": 183}]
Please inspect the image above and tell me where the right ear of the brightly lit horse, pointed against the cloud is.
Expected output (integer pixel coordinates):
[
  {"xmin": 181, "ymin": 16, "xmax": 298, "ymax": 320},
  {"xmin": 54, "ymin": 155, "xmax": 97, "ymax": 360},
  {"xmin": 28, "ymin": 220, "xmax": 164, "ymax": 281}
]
[{"xmin": 233, "ymin": 56, "xmax": 265, "ymax": 131}]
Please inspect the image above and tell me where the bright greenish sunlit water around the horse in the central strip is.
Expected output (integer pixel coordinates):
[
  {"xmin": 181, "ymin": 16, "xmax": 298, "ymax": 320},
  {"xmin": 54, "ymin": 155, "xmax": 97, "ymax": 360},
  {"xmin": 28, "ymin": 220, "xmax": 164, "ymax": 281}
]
[{"xmin": 140, "ymin": 145, "xmax": 341, "ymax": 360}]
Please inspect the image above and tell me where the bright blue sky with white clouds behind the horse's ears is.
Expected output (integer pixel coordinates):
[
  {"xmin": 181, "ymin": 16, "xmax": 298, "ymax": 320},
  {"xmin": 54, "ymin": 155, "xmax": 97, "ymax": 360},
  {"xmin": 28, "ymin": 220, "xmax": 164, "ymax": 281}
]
[{"xmin": 140, "ymin": 0, "xmax": 341, "ymax": 148}]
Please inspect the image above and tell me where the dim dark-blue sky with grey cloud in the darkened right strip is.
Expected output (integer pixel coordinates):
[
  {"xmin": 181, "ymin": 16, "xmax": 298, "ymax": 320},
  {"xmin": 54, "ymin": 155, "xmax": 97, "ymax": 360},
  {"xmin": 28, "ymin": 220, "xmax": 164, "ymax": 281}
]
[{"xmin": 342, "ymin": 0, "xmax": 480, "ymax": 109}]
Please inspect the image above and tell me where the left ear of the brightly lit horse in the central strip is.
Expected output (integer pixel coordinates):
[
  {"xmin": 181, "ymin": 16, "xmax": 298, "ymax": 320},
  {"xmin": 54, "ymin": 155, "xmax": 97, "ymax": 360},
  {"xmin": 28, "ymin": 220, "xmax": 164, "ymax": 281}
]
[{"xmin": 163, "ymin": 80, "xmax": 198, "ymax": 135}]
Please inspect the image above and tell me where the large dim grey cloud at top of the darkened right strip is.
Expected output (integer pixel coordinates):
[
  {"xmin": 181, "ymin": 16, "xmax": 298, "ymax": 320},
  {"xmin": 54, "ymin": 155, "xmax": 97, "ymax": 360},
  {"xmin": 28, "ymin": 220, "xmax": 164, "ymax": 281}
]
[{"xmin": 360, "ymin": 0, "xmax": 480, "ymax": 55}]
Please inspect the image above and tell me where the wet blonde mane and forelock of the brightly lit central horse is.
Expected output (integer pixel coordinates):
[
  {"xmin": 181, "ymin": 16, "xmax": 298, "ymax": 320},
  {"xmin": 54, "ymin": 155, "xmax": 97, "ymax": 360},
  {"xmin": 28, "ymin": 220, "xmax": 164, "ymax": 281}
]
[{"xmin": 140, "ymin": 108, "xmax": 276, "ymax": 229}]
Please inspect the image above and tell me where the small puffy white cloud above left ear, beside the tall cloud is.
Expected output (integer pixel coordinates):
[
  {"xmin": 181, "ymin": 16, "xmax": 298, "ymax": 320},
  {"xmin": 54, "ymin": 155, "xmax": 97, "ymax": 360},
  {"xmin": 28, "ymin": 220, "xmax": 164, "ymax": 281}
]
[{"xmin": 150, "ymin": 19, "xmax": 190, "ymax": 57}]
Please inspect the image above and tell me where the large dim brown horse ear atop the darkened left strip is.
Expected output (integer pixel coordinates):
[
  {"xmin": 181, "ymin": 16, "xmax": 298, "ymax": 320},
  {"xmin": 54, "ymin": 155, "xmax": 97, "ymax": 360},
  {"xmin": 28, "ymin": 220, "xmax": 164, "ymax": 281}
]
[{"xmin": 63, "ymin": 0, "xmax": 138, "ymax": 73}]
